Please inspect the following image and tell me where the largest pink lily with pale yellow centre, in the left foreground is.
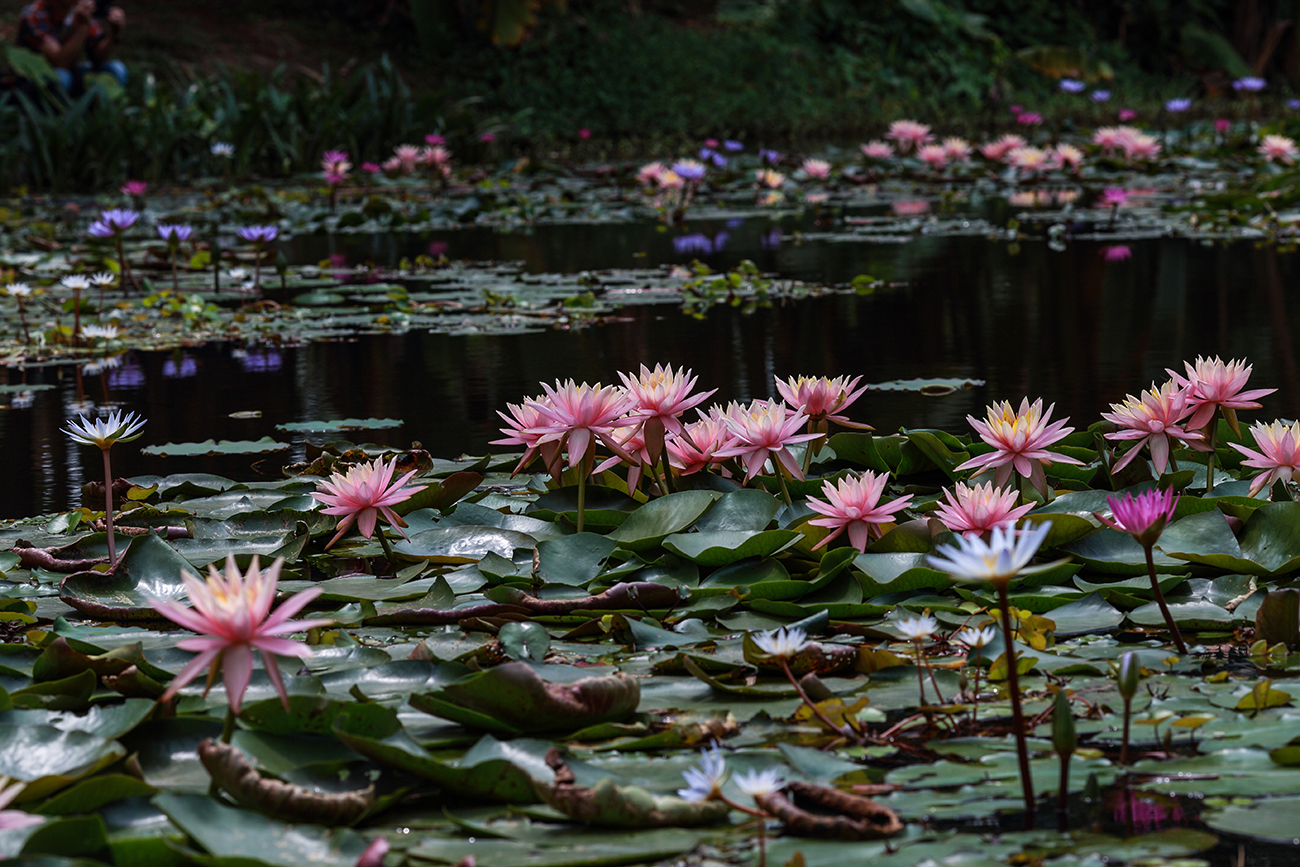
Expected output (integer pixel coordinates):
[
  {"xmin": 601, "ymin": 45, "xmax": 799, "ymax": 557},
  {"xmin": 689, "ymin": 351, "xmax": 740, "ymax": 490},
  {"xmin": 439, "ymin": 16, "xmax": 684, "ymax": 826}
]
[{"xmin": 150, "ymin": 555, "xmax": 333, "ymax": 715}]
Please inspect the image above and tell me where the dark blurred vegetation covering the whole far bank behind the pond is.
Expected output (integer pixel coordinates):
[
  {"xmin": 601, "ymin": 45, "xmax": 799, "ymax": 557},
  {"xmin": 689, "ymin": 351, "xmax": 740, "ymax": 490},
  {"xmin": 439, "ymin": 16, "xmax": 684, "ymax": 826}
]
[{"xmin": 0, "ymin": 0, "xmax": 1300, "ymax": 187}]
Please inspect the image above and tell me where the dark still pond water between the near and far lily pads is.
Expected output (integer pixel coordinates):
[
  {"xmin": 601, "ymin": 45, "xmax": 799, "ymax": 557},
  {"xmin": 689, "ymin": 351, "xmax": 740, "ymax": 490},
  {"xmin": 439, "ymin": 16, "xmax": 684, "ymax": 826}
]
[{"xmin": 0, "ymin": 218, "xmax": 1300, "ymax": 517}]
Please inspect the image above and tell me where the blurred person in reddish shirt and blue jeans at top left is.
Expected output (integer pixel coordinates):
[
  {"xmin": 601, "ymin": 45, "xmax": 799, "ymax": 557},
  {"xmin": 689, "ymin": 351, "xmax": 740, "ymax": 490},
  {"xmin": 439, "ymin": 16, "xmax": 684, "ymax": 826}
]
[{"xmin": 18, "ymin": 0, "xmax": 126, "ymax": 96}]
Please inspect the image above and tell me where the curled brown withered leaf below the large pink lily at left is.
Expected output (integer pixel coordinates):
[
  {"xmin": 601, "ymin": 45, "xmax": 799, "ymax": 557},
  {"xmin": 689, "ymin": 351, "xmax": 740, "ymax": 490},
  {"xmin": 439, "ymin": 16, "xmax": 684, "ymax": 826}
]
[{"xmin": 199, "ymin": 738, "xmax": 374, "ymax": 827}]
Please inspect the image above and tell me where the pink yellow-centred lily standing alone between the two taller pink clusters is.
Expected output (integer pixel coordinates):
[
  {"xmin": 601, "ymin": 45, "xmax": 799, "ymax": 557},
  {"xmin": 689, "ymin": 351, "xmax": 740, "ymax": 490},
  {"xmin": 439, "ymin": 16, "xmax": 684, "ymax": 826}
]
[{"xmin": 957, "ymin": 398, "xmax": 1082, "ymax": 497}]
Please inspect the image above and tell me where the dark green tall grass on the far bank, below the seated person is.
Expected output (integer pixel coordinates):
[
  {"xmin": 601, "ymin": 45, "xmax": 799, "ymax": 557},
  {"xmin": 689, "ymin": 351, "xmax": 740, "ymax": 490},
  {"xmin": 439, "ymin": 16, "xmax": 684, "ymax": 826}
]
[{"xmin": 0, "ymin": 58, "xmax": 437, "ymax": 192}]
